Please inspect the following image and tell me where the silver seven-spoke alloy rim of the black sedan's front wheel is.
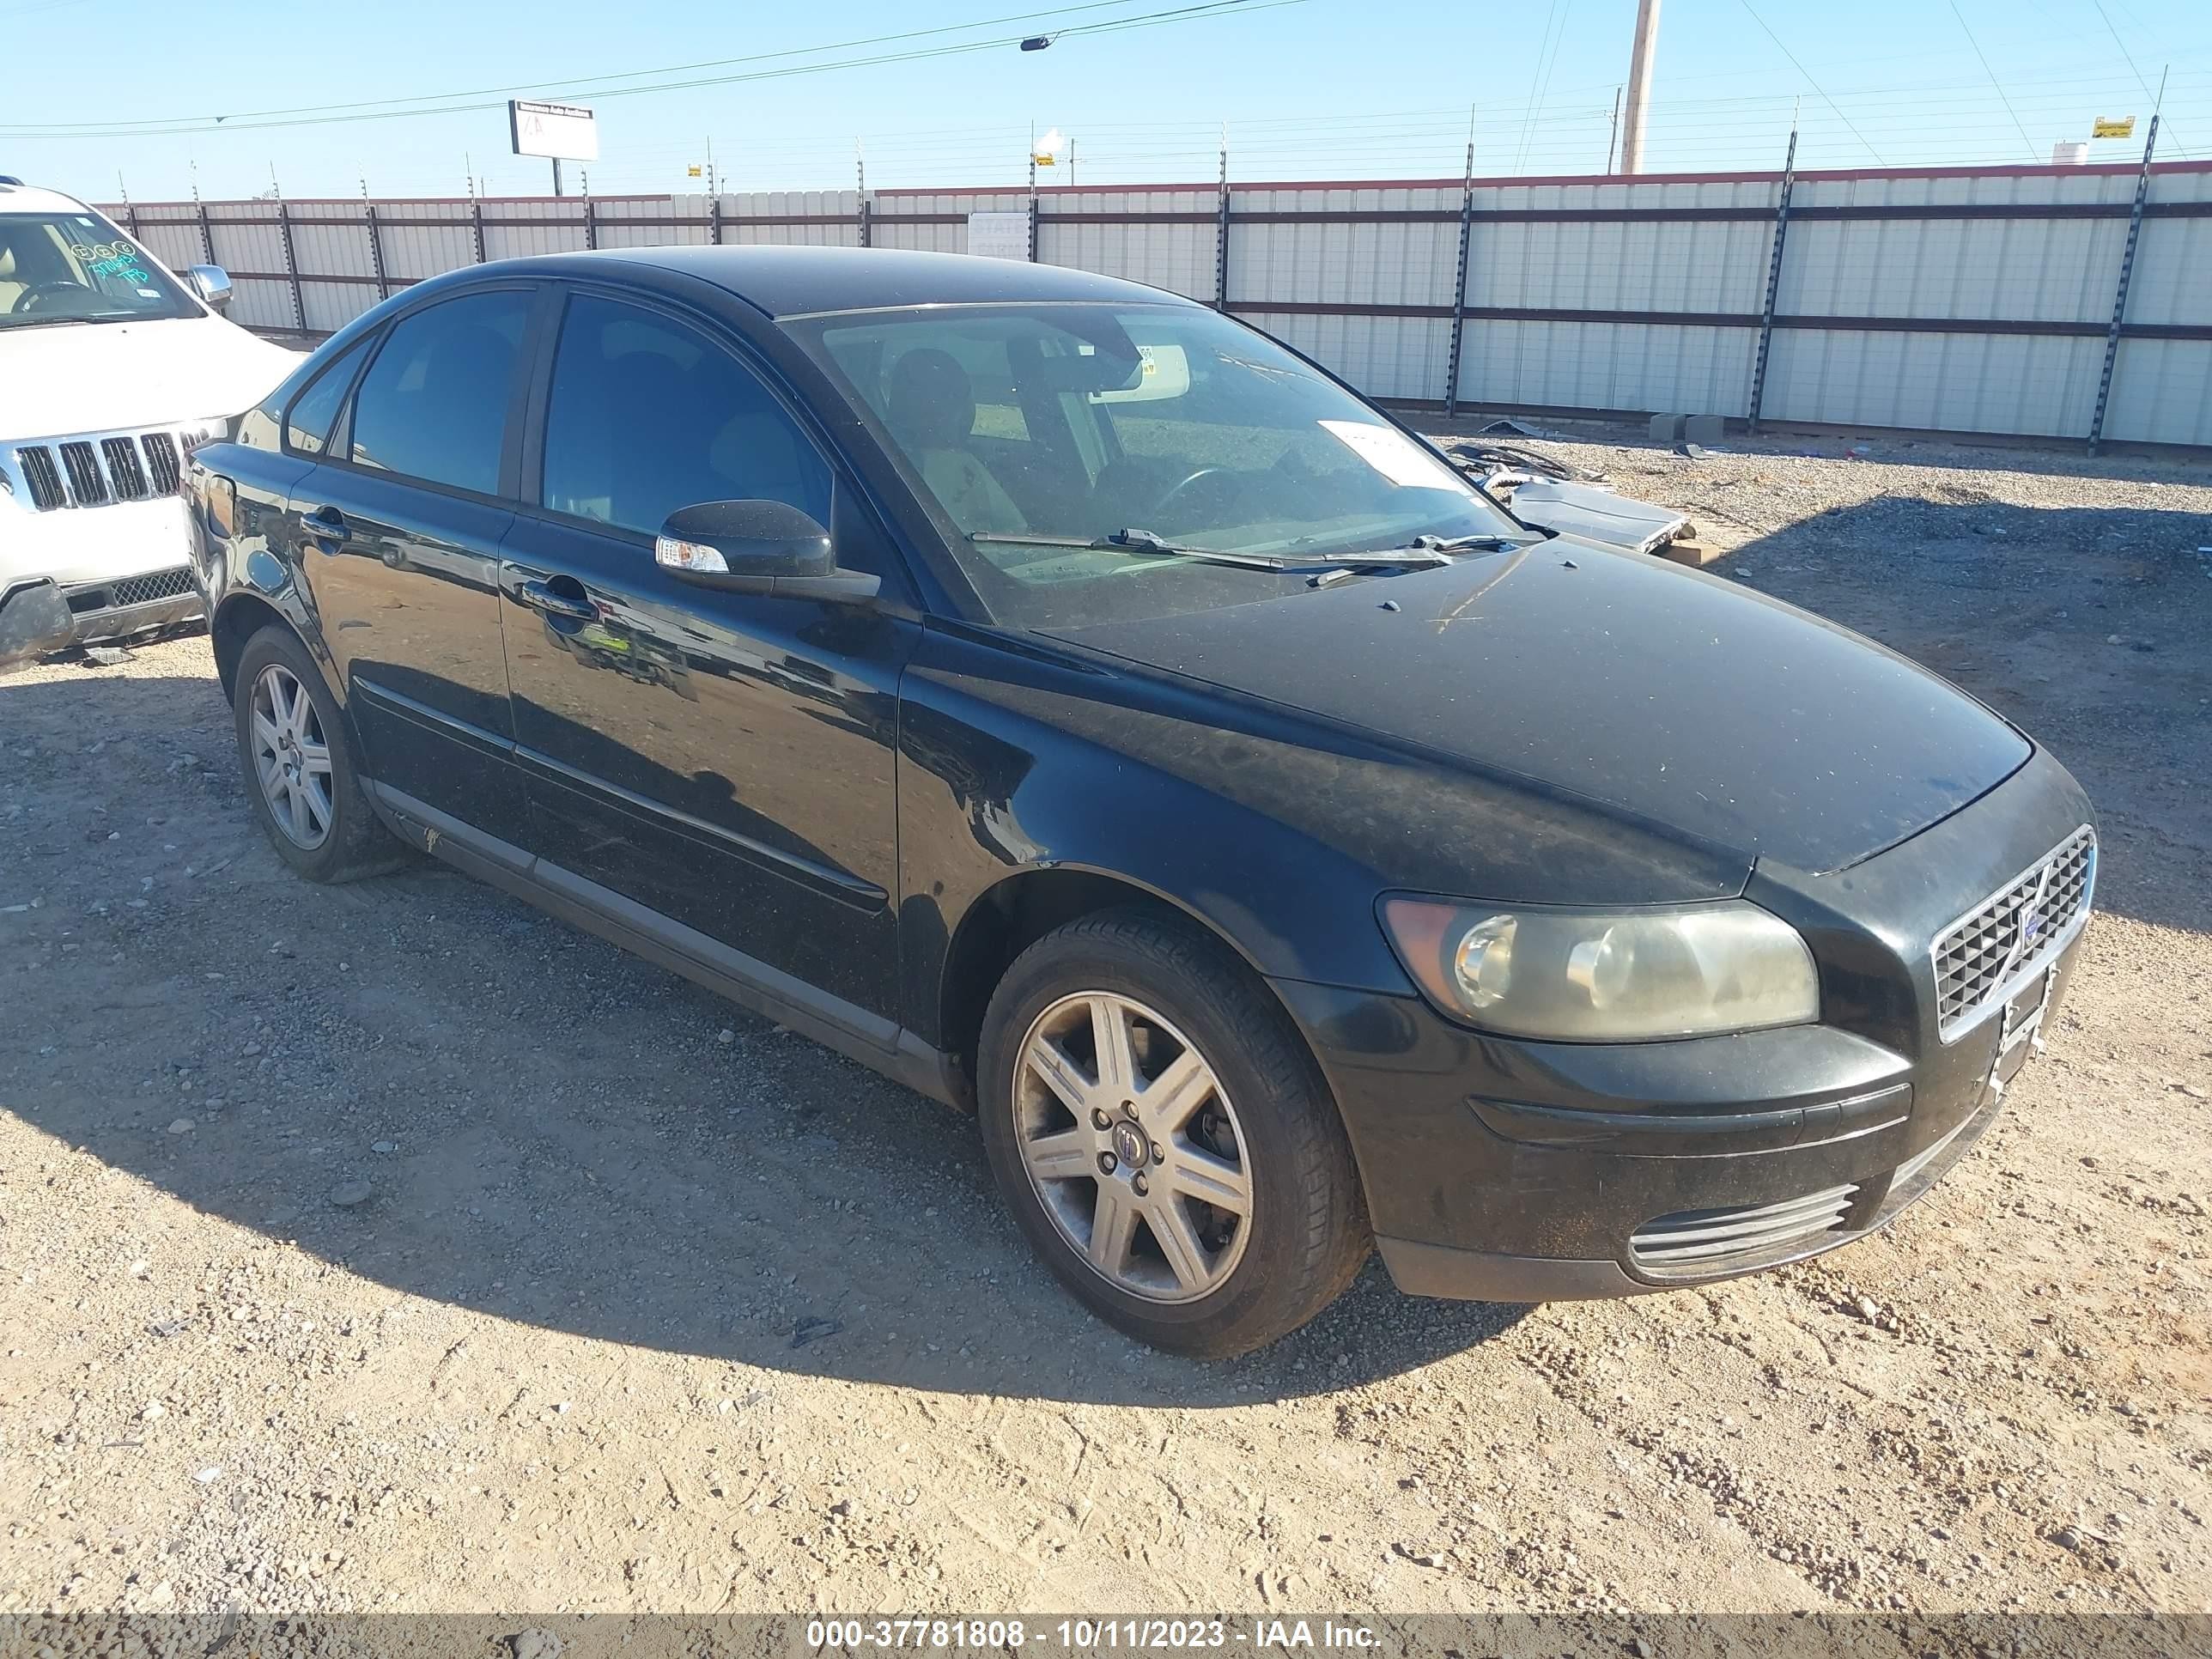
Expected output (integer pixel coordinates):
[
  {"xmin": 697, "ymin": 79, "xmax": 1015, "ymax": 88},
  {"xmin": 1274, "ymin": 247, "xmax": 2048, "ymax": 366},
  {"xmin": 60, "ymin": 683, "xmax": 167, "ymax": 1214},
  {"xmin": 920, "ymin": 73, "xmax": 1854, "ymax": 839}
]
[{"xmin": 1013, "ymin": 991, "xmax": 1252, "ymax": 1303}]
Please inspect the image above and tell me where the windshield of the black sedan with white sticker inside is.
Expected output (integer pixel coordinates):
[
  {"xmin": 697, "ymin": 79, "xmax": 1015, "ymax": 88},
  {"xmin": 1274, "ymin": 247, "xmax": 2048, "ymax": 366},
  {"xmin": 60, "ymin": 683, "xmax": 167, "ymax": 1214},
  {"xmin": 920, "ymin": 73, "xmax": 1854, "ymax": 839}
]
[{"xmin": 792, "ymin": 305, "xmax": 1524, "ymax": 629}]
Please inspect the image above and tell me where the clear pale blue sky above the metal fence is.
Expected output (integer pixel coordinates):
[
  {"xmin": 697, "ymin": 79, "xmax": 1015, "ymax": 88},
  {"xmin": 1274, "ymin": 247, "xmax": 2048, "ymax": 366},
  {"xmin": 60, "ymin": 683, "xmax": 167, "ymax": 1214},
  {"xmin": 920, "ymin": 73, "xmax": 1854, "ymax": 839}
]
[{"xmin": 13, "ymin": 0, "xmax": 2212, "ymax": 201}]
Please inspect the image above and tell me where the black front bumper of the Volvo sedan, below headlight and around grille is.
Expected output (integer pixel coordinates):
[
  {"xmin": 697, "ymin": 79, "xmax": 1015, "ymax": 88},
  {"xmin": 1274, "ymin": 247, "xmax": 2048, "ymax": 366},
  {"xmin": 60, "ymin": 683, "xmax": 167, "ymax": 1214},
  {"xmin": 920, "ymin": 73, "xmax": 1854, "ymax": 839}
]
[{"xmin": 1274, "ymin": 754, "xmax": 2088, "ymax": 1301}]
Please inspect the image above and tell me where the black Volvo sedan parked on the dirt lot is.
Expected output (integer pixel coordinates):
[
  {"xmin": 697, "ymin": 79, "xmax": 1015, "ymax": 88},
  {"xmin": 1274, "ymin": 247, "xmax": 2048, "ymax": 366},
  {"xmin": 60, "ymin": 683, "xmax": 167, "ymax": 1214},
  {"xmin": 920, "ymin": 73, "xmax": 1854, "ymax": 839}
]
[{"xmin": 191, "ymin": 248, "xmax": 2097, "ymax": 1356}]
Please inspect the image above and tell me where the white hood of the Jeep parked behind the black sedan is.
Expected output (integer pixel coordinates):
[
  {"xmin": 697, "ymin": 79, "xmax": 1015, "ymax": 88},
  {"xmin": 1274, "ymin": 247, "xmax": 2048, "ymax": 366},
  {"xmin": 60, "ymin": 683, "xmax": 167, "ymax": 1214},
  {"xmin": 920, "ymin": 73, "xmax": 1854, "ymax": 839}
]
[{"xmin": 0, "ymin": 316, "xmax": 301, "ymax": 442}]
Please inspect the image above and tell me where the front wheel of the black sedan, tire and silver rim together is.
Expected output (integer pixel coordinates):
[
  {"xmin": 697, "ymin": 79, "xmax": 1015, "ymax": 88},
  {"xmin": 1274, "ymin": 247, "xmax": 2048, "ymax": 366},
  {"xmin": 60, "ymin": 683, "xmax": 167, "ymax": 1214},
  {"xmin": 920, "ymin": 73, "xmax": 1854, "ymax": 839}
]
[{"xmin": 980, "ymin": 911, "xmax": 1370, "ymax": 1358}]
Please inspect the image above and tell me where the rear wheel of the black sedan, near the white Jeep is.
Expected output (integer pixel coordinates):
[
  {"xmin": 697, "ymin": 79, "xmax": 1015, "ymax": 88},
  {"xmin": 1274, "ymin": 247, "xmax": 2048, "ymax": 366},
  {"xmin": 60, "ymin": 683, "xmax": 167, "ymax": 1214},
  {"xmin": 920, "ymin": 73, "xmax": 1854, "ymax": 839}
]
[{"xmin": 234, "ymin": 626, "xmax": 404, "ymax": 883}]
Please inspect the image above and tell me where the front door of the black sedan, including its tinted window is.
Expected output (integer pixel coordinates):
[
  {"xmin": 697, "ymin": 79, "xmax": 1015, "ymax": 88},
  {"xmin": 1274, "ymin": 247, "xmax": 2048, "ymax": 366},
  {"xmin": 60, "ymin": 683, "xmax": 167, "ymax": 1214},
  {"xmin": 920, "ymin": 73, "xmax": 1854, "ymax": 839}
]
[{"xmin": 500, "ymin": 292, "xmax": 915, "ymax": 1042}]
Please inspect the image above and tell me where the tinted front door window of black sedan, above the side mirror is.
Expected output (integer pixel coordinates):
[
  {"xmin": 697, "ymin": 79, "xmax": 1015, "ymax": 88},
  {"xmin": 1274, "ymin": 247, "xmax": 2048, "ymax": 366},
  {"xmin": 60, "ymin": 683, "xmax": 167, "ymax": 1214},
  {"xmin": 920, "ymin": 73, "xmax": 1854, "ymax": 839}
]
[{"xmin": 544, "ymin": 295, "xmax": 830, "ymax": 535}]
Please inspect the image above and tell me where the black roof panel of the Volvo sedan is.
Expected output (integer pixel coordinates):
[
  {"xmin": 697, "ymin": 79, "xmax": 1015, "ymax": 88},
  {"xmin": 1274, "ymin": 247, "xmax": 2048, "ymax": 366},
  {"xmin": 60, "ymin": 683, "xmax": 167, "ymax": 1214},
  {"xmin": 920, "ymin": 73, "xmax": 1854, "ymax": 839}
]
[{"xmin": 508, "ymin": 246, "xmax": 1192, "ymax": 319}]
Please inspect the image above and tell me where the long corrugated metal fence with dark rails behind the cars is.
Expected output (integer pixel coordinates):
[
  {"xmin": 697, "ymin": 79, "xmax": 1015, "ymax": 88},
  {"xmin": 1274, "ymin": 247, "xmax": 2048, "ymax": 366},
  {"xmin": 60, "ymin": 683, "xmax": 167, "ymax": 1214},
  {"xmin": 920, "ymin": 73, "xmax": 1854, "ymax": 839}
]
[{"xmin": 111, "ymin": 161, "xmax": 2212, "ymax": 445}]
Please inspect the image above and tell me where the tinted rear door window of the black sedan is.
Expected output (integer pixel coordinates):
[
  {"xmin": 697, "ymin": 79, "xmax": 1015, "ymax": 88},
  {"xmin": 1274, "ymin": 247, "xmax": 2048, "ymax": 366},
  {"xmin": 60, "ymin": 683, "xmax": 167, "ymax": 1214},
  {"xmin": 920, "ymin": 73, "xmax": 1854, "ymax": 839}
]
[{"xmin": 354, "ymin": 289, "xmax": 531, "ymax": 495}]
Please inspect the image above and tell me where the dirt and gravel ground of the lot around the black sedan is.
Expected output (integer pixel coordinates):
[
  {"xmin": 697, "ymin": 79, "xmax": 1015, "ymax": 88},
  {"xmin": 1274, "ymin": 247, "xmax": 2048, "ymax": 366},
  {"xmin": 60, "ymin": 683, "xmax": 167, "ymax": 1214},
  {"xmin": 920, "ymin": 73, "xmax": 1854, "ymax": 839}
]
[{"xmin": 0, "ymin": 428, "xmax": 2212, "ymax": 1613}]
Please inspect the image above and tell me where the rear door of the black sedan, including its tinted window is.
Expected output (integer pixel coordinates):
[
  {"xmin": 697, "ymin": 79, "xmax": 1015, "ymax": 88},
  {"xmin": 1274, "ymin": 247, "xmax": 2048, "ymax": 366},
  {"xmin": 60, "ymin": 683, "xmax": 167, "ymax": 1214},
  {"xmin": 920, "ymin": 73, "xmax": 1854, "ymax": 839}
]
[{"xmin": 288, "ymin": 285, "xmax": 535, "ymax": 845}]
